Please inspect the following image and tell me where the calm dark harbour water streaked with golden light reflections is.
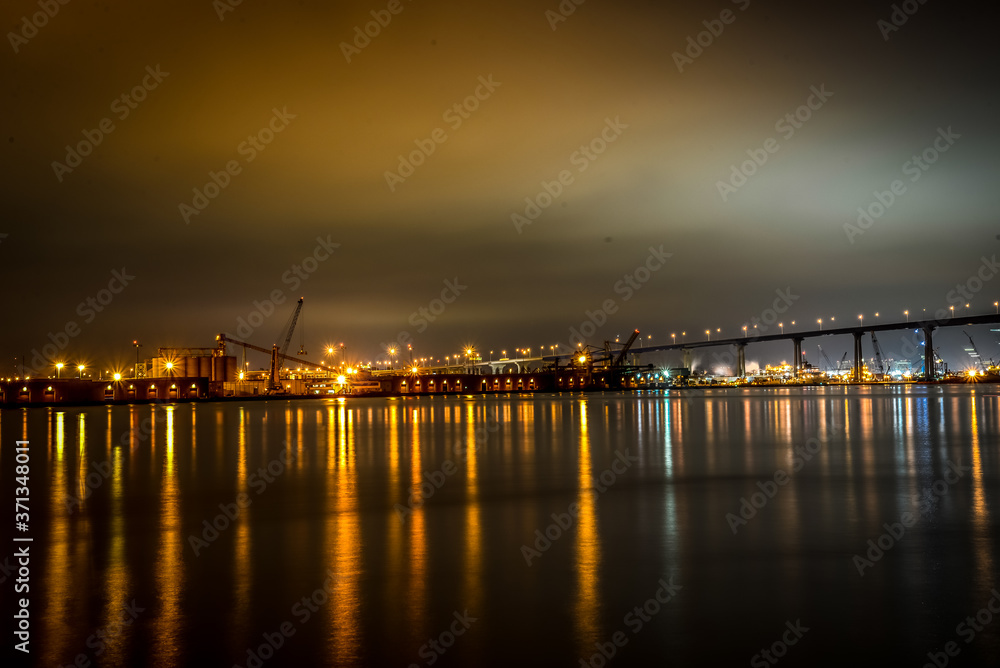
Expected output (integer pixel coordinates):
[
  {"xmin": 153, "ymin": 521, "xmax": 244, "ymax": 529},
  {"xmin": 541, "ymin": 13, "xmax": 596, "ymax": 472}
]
[{"xmin": 0, "ymin": 386, "xmax": 1000, "ymax": 668}]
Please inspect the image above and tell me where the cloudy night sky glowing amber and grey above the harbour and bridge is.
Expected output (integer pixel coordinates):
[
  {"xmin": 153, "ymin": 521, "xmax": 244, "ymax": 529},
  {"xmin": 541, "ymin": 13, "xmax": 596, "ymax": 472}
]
[{"xmin": 0, "ymin": 0, "xmax": 1000, "ymax": 375}]
